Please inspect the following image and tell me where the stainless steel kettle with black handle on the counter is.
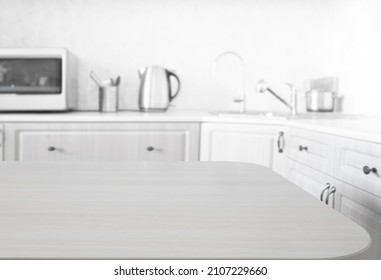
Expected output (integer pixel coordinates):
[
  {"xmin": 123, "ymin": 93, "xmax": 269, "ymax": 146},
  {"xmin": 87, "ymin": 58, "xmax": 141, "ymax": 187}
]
[{"xmin": 139, "ymin": 66, "xmax": 180, "ymax": 111}]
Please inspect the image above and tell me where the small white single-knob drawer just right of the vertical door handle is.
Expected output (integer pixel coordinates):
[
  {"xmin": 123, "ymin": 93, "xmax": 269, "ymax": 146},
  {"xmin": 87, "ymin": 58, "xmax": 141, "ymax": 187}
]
[{"xmin": 285, "ymin": 128, "xmax": 333, "ymax": 175}]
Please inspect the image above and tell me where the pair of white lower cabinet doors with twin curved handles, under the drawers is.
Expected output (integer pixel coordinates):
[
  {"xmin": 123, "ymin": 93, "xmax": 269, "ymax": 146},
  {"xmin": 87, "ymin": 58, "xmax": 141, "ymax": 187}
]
[{"xmin": 287, "ymin": 160, "xmax": 381, "ymax": 259}]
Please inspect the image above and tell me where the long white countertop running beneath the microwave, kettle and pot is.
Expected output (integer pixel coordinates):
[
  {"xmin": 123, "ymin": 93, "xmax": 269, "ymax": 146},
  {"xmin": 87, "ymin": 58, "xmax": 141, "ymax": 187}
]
[{"xmin": 0, "ymin": 110, "xmax": 381, "ymax": 143}]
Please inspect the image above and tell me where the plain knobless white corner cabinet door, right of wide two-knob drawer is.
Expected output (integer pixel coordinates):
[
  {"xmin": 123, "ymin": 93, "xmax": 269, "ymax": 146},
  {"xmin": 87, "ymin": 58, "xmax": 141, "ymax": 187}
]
[{"xmin": 200, "ymin": 123, "xmax": 279, "ymax": 167}]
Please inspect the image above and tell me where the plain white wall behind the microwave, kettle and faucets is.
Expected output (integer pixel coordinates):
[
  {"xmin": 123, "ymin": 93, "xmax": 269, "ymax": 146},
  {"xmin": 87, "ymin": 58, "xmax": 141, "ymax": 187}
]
[{"xmin": 0, "ymin": 0, "xmax": 381, "ymax": 113}]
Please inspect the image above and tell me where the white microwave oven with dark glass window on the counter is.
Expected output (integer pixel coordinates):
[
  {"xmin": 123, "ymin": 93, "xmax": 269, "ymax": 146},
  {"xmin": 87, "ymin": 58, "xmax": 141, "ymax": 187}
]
[{"xmin": 0, "ymin": 48, "xmax": 77, "ymax": 111}]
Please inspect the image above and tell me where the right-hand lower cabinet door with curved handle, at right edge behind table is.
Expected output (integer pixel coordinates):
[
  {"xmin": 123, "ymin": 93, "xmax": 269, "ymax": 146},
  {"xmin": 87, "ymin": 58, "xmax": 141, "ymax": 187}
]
[{"xmin": 329, "ymin": 179, "xmax": 381, "ymax": 259}]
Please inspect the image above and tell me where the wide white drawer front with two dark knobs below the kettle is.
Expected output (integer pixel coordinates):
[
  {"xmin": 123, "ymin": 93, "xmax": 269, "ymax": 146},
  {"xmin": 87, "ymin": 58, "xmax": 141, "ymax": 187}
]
[{"xmin": 4, "ymin": 123, "xmax": 199, "ymax": 161}]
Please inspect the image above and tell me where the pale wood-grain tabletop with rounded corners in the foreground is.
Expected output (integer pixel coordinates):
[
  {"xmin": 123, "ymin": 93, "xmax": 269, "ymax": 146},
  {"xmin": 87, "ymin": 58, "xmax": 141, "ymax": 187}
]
[{"xmin": 0, "ymin": 162, "xmax": 371, "ymax": 259}]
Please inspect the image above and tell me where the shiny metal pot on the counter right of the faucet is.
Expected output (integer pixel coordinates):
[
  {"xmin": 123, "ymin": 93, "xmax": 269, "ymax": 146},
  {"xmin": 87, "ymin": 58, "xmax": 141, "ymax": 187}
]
[{"xmin": 306, "ymin": 89, "xmax": 335, "ymax": 112}]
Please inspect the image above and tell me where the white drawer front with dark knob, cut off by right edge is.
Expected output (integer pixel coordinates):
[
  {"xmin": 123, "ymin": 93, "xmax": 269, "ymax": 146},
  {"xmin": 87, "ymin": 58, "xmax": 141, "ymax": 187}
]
[{"xmin": 334, "ymin": 138, "xmax": 381, "ymax": 197}]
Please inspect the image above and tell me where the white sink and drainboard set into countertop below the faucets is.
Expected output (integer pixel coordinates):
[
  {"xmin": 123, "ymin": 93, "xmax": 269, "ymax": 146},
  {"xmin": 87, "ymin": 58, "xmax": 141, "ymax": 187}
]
[{"xmin": 212, "ymin": 111, "xmax": 366, "ymax": 120}]
